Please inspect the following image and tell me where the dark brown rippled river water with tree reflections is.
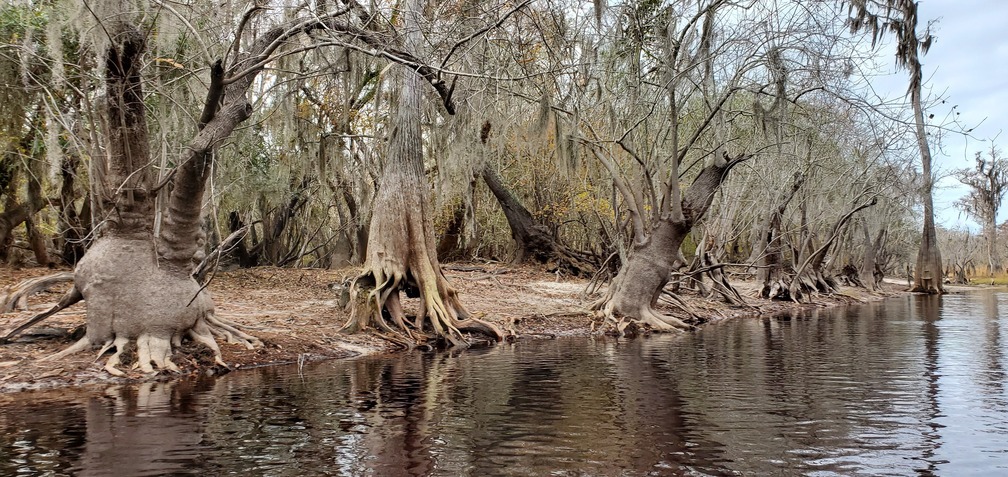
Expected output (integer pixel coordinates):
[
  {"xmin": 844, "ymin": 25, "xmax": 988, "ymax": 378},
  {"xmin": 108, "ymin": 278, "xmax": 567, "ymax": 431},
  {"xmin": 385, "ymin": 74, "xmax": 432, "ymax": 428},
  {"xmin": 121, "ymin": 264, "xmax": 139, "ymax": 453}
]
[{"xmin": 0, "ymin": 292, "xmax": 1008, "ymax": 476}]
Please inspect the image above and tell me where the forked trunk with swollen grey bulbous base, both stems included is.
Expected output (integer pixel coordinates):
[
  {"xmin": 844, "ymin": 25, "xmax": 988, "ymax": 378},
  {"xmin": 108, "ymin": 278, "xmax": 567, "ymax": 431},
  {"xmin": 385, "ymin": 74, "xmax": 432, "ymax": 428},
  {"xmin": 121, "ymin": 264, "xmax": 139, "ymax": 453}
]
[{"xmin": 46, "ymin": 22, "xmax": 282, "ymax": 374}]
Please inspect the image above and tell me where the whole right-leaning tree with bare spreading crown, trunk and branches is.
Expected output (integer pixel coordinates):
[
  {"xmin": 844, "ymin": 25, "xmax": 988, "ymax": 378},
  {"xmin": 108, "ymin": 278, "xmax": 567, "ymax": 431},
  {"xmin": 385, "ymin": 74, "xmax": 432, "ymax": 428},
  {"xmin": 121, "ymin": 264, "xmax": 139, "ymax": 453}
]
[{"xmin": 581, "ymin": 0, "xmax": 822, "ymax": 331}]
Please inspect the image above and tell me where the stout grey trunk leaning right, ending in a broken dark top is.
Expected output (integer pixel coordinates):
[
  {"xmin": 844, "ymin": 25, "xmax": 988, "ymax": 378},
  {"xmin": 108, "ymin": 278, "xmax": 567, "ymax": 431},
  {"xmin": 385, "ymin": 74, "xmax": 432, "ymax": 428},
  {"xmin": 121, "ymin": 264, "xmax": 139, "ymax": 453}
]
[{"xmin": 593, "ymin": 156, "xmax": 748, "ymax": 332}]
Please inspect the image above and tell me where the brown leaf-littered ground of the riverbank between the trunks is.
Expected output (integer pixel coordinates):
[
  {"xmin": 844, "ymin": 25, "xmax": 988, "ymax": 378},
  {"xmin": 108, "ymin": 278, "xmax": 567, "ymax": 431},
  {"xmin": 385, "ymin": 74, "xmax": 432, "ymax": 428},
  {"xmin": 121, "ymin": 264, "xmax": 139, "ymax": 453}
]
[{"xmin": 0, "ymin": 263, "xmax": 919, "ymax": 392}]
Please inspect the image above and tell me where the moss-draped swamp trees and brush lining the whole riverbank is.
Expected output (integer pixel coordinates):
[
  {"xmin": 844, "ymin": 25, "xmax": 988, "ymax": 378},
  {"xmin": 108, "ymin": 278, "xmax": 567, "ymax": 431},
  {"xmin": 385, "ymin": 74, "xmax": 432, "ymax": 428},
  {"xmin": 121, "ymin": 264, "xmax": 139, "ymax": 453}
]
[{"xmin": 0, "ymin": 0, "xmax": 1006, "ymax": 374}]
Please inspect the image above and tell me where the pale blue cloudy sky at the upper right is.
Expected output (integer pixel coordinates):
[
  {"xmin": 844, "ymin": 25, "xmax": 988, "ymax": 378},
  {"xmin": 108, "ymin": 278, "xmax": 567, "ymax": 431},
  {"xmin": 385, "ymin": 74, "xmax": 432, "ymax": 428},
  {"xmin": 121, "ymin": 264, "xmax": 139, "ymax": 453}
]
[{"xmin": 872, "ymin": 0, "xmax": 1008, "ymax": 231}]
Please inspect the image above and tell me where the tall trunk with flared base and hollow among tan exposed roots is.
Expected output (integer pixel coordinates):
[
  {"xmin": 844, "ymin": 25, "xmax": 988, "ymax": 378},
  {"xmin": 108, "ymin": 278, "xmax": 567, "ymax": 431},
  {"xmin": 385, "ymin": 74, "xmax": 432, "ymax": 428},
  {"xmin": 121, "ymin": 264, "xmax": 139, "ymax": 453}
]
[{"xmin": 345, "ymin": 0, "xmax": 503, "ymax": 346}]
